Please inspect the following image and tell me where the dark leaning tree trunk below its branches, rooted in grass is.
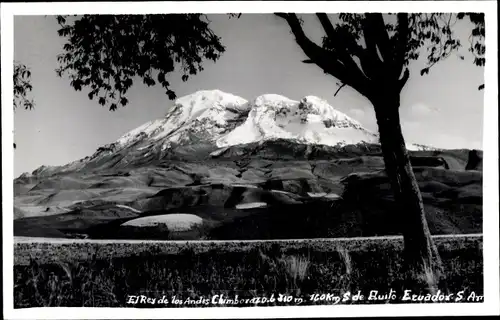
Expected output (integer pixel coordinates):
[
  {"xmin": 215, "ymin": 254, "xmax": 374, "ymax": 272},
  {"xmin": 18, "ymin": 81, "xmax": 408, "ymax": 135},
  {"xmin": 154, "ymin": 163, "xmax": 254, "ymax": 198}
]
[{"xmin": 373, "ymin": 94, "xmax": 442, "ymax": 289}]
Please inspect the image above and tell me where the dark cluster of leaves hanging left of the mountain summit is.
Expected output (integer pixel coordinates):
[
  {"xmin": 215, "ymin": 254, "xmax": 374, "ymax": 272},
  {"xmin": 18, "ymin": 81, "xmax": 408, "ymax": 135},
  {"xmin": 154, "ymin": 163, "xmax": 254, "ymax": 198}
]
[{"xmin": 56, "ymin": 14, "xmax": 225, "ymax": 110}]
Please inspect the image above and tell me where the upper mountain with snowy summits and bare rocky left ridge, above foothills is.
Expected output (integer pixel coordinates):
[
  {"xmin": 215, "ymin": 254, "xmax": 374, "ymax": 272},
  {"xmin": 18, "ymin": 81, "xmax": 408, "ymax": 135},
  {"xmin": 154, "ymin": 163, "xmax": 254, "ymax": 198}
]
[{"xmin": 23, "ymin": 90, "xmax": 434, "ymax": 176}]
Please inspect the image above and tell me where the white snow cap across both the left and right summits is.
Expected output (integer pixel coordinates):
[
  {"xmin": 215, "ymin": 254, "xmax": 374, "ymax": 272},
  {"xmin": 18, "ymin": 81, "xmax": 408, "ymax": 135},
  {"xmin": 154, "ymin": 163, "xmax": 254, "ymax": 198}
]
[{"xmin": 103, "ymin": 90, "xmax": 378, "ymax": 152}]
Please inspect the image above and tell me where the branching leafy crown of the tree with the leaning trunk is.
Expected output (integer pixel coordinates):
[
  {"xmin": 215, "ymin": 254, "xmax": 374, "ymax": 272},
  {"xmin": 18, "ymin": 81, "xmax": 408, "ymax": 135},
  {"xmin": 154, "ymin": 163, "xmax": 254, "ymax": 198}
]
[{"xmin": 276, "ymin": 13, "xmax": 485, "ymax": 98}]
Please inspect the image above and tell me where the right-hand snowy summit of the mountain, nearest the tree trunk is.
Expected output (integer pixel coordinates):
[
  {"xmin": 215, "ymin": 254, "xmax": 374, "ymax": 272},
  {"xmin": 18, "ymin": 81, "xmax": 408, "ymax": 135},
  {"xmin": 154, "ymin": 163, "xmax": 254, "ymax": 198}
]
[{"xmin": 217, "ymin": 94, "xmax": 377, "ymax": 147}]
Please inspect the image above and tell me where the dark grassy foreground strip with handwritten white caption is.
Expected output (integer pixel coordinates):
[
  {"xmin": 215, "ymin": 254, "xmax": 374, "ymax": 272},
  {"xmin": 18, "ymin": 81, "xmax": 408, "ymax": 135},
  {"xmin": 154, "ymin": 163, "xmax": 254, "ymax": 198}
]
[{"xmin": 14, "ymin": 237, "xmax": 483, "ymax": 308}]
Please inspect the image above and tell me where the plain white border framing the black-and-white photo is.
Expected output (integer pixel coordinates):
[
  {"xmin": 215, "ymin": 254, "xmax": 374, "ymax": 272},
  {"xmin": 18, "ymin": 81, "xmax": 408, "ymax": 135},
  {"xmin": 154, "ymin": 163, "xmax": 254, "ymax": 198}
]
[{"xmin": 1, "ymin": 1, "xmax": 500, "ymax": 319}]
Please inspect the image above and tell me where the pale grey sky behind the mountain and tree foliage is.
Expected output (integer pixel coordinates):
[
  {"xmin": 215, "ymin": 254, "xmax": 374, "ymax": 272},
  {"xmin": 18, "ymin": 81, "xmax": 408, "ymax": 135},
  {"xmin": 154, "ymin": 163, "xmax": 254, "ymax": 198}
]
[{"xmin": 14, "ymin": 14, "xmax": 484, "ymax": 176}]
